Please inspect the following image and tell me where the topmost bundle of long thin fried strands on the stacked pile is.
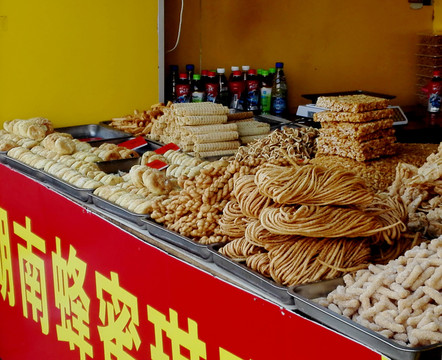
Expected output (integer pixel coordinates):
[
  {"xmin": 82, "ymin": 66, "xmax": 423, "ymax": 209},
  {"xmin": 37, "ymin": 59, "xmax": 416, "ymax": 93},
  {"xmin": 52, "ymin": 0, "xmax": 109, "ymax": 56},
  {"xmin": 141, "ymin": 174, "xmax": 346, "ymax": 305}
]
[{"xmin": 255, "ymin": 164, "xmax": 374, "ymax": 205}]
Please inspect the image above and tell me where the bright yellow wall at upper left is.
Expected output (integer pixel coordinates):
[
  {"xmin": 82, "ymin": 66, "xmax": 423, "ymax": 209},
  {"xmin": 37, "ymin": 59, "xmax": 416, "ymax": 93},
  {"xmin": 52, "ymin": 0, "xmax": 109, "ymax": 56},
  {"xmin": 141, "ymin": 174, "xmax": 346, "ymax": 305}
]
[{"xmin": 0, "ymin": 0, "xmax": 159, "ymax": 126}]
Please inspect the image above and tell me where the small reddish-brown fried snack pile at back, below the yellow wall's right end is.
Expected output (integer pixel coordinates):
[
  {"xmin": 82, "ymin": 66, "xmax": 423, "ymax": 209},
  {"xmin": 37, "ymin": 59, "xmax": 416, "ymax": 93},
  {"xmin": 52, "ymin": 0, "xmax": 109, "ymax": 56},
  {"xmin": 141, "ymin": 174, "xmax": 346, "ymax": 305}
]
[{"xmin": 109, "ymin": 103, "xmax": 167, "ymax": 136}]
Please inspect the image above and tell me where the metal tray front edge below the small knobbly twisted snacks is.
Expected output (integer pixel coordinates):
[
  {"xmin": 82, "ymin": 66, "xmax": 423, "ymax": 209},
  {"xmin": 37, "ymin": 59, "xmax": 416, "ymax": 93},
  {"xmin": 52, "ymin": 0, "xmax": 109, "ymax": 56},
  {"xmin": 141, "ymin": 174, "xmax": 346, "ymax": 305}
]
[{"xmin": 142, "ymin": 219, "xmax": 212, "ymax": 261}]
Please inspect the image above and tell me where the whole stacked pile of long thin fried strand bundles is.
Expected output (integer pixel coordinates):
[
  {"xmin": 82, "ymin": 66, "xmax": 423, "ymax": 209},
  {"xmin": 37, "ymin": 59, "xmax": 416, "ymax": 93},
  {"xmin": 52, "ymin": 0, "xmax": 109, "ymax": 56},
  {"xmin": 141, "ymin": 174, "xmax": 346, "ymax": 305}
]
[{"xmin": 219, "ymin": 164, "xmax": 406, "ymax": 286}]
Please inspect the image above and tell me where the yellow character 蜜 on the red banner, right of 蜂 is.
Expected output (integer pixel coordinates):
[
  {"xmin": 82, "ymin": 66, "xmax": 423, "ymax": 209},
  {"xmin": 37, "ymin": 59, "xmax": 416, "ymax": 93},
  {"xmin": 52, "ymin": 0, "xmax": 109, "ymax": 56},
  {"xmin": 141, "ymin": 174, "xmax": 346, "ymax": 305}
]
[{"xmin": 95, "ymin": 272, "xmax": 141, "ymax": 360}]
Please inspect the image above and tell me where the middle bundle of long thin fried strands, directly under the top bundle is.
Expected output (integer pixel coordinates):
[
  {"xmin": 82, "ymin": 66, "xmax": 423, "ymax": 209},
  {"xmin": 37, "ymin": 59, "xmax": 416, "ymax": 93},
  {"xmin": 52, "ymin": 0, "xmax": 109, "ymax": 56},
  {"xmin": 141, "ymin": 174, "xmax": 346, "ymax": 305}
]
[{"xmin": 259, "ymin": 205, "xmax": 388, "ymax": 238}]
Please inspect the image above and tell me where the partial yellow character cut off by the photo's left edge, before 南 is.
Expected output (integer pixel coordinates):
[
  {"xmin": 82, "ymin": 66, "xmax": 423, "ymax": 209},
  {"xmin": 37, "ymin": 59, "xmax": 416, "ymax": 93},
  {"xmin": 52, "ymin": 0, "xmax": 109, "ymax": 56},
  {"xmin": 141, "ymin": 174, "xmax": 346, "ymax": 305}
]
[{"xmin": 0, "ymin": 208, "xmax": 15, "ymax": 306}]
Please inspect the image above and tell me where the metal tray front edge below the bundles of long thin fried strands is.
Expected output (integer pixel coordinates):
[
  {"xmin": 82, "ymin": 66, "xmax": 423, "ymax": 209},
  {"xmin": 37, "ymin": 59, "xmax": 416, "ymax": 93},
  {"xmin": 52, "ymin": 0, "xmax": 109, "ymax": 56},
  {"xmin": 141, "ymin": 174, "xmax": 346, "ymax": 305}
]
[{"xmin": 209, "ymin": 244, "xmax": 293, "ymax": 305}]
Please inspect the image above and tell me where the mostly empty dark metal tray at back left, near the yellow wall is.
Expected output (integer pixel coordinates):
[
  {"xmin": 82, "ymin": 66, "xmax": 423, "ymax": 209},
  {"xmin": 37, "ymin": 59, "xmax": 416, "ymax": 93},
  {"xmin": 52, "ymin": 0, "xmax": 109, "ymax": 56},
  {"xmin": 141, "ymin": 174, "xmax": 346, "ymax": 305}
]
[{"xmin": 55, "ymin": 124, "xmax": 130, "ymax": 141}]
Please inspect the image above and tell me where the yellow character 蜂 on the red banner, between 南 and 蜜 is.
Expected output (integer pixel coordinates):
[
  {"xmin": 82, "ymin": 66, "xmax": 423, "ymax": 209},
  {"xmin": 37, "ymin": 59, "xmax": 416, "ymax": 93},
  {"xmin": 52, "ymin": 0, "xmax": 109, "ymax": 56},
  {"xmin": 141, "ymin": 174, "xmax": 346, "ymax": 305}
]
[{"xmin": 52, "ymin": 237, "xmax": 93, "ymax": 360}]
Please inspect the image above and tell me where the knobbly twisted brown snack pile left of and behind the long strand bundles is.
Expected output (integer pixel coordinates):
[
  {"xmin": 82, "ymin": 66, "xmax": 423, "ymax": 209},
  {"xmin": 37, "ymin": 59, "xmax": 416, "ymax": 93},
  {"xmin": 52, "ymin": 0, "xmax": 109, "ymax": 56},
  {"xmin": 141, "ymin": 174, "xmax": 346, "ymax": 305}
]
[{"xmin": 151, "ymin": 128, "xmax": 317, "ymax": 244}]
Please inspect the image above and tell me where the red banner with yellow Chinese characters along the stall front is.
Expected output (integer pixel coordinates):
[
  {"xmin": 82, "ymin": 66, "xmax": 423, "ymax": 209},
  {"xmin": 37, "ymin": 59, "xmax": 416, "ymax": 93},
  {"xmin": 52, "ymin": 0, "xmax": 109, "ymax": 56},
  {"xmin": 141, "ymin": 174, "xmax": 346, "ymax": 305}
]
[{"xmin": 0, "ymin": 165, "xmax": 381, "ymax": 360}]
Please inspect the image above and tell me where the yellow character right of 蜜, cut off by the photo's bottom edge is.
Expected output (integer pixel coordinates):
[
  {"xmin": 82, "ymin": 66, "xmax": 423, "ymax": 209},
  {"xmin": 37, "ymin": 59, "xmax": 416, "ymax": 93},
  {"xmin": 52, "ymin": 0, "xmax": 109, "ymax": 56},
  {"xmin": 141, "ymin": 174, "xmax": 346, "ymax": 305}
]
[{"xmin": 147, "ymin": 305, "xmax": 207, "ymax": 360}]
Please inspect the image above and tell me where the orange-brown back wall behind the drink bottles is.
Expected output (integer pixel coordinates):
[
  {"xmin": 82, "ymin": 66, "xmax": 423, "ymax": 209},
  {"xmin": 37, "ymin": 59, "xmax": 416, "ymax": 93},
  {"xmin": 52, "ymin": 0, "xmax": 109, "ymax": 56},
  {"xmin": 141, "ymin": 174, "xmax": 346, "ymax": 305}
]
[{"xmin": 165, "ymin": 0, "xmax": 434, "ymax": 112}]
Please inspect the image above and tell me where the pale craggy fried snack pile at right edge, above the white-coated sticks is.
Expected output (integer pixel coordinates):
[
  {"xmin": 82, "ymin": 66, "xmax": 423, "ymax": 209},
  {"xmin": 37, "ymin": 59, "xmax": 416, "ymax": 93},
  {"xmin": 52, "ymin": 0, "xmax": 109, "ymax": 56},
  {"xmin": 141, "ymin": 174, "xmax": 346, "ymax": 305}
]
[{"xmin": 389, "ymin": 143, "xmax": 442, "ymax": 237}]
